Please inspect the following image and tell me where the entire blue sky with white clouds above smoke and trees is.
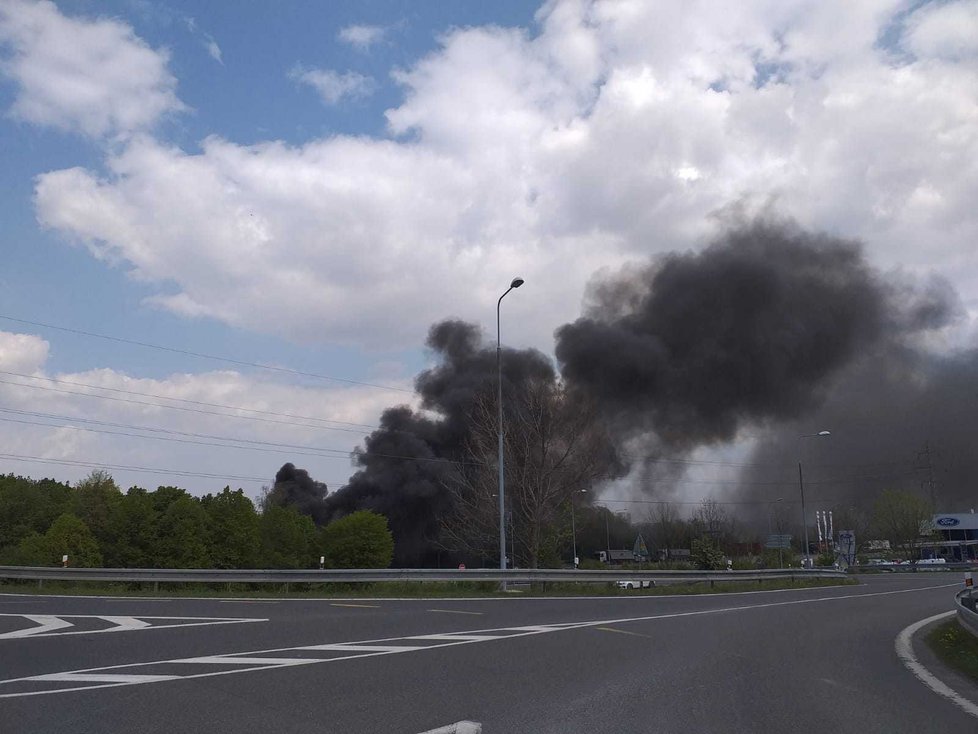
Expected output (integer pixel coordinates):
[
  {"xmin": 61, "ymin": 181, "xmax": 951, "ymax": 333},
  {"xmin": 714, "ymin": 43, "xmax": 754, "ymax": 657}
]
[{"xmin": 0, "ymin": 0, "xmax": 978, "ymax": 494}]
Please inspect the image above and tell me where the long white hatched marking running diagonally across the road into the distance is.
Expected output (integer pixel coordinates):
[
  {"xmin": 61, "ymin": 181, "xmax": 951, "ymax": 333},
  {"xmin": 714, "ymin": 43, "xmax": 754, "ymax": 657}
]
[{"xmin": 0, "ymin": 583, "xmax": 960, "ymax": 699}]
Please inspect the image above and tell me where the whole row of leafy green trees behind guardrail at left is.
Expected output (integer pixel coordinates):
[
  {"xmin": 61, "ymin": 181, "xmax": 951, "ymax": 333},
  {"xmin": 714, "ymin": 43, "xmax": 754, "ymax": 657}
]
[{"xmin": 0, "ymin": 470, "xmax": 394, "ymax": 569}]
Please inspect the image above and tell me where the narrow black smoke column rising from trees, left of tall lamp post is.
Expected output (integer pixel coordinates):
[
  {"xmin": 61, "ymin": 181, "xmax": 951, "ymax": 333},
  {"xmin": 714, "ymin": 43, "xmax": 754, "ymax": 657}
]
[{"xmin": 327, "ymin": 321, "xmax": 556, "ymax": 566}]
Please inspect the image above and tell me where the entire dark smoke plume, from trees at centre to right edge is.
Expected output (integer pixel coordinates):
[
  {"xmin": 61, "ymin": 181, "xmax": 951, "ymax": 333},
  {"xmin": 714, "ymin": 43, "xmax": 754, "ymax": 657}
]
[{"xmin": 324, "ymin": 218, "xmax": 978, "ymax": 566}]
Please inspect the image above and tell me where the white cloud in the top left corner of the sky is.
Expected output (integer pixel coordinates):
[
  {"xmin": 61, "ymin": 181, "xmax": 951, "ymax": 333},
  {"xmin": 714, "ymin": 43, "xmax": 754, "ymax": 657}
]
[{"xmin": 0, "ymin": 0, "xmax": 184, "ymax": 137}]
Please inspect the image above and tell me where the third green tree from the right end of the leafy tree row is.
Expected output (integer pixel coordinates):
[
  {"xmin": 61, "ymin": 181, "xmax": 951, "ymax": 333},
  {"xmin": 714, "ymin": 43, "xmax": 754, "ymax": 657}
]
[{"xmin": 201, "ymin": 487, "xmax": 261, "ymax": 568}]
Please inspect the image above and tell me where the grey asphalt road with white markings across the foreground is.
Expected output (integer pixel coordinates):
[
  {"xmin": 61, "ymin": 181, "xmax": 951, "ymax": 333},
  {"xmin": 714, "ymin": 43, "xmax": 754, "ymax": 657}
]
[{"xmin": 0, "ymin": 574, "xmax": 978, "ymax": 734}]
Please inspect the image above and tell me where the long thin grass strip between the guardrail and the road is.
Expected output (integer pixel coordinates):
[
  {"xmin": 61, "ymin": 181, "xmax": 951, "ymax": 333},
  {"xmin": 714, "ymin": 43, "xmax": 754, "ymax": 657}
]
[{"xmin": 0, "ymin": 579, "xmax": 858, "ymax": 599}]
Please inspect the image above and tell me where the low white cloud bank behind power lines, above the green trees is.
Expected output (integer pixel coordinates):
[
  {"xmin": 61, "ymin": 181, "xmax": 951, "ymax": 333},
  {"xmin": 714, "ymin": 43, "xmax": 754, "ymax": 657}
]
[{"xmin": 0, "ymin": 332, "xmax": 410, "ymax": 496}]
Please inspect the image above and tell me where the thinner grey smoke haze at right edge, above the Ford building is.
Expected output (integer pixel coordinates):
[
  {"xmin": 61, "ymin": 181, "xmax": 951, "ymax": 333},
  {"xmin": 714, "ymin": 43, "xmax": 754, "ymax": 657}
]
[{"xmin": 737, "ymin": 344, "xmax": 978, "ymax": 512}]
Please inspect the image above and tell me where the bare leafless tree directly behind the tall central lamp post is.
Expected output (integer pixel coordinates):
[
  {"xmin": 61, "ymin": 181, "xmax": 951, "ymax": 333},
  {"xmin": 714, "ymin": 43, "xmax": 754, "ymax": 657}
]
[{"xmin": 442, "ymin": 380, "xmax": 614, "ymax": 568}]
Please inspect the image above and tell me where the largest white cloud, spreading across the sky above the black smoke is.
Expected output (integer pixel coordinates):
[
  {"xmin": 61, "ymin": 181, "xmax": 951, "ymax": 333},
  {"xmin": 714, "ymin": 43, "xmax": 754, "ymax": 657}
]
[{"xmin": 30, "ymin": 0, "xmax": 978, "ymax": 348}]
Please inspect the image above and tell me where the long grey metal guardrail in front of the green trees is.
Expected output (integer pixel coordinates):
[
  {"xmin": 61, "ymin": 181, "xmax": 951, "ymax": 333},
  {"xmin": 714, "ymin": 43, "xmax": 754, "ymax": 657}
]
[{"xmin": 0, "ymin": 566, "xmax": 846, "ymax": 584}]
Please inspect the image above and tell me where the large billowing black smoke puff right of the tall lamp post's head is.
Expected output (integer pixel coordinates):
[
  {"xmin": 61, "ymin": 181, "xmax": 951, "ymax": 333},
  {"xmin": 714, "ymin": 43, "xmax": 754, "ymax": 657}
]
[{"xmin": 556, "ymin": 221, "xmax": 886, "ymax": 450}]
